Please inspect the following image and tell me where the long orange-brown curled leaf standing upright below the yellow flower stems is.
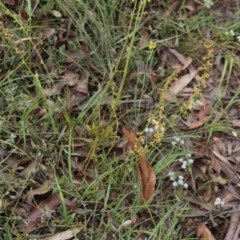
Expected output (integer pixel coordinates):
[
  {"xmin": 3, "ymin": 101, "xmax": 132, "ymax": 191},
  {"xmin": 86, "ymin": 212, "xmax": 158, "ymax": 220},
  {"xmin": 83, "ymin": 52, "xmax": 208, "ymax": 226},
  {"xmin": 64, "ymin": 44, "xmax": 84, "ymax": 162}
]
[{"xmin": 122, "ymin": 127, "xmax": 156, "ymax": 201}]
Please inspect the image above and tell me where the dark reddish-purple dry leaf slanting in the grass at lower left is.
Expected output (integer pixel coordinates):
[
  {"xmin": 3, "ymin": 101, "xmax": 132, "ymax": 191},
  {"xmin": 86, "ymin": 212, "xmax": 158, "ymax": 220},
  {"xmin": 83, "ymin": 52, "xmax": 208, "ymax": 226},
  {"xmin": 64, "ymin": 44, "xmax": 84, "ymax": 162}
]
[{"xmin": 26, "ymin": 193, "xmax": 61, "ymax": 233}]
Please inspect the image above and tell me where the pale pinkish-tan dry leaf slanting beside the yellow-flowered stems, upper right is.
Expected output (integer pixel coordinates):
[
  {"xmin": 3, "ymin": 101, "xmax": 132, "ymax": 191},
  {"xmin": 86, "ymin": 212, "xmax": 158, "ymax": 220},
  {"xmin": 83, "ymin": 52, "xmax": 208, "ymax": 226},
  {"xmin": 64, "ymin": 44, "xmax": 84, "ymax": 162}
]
[{"xmin": 169, "ymin": 70, "xmax": 198, "ymax": 95}]
